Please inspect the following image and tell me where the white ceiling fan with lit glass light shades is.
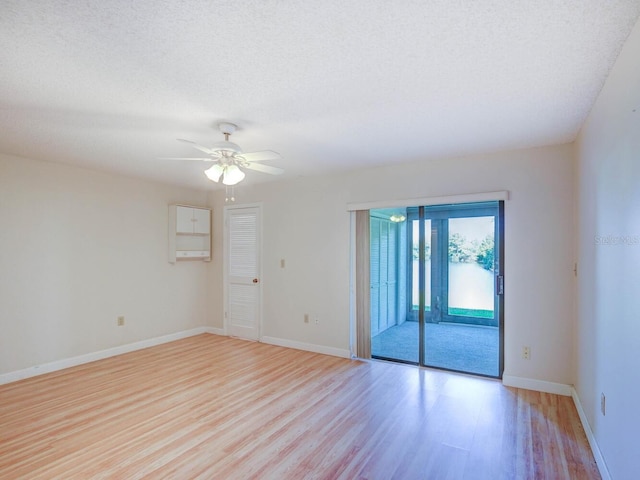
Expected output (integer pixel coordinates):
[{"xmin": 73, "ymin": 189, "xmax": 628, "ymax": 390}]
[{"xmin": 166, "ymin": 122, "xmax": 284, "ymax": 186}]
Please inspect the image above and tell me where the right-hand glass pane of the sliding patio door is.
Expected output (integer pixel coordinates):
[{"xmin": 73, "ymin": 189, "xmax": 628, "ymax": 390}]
[{"xmin": 423, "ymin": 203, "xmax": 500, "ymax": 377}]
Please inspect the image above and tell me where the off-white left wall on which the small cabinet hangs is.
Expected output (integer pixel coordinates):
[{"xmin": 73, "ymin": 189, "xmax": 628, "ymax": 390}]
[{"xmin": 0, "ymin": 155, "xmax": 209, "ymax": 374}]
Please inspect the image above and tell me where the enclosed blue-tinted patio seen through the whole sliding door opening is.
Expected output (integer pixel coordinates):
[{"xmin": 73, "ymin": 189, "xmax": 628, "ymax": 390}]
[{"xmin": 371, "ymin": 202, "xmax": 503, "ymax": 377}]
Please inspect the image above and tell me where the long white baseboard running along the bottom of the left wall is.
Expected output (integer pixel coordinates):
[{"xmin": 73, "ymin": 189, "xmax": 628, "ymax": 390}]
[{"xmin": 0, "ymin": 327, "xmax": 218, "ymax": 385}]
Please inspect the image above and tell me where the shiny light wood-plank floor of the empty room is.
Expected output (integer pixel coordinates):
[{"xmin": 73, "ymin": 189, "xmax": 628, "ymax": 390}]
[{"xmin": 0, "ymin": 334, "xmax": 600, "ymax": 480}]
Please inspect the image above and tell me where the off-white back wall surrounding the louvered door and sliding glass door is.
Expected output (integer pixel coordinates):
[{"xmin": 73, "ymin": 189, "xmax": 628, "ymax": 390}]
[{"xmin": 211, "ymin": 145, "xmax": 575, "ymax": 384}]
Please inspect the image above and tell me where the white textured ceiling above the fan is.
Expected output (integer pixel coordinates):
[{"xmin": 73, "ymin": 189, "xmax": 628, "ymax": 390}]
[{"xmin": 0, "ymin": 0, "xmax": 640, "ymax": 188}]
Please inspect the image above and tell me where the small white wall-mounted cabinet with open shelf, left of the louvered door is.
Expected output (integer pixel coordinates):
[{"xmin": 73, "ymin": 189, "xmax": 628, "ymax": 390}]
[{"xmin": 169, "ymin": 205, "xmax": 211, "ymax": 263}]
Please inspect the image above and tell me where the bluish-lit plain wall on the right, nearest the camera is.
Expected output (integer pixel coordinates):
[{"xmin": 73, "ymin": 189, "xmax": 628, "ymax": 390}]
[{"xmin": 576, "ymin": 15, "xmax": 640, "ymax": 479}]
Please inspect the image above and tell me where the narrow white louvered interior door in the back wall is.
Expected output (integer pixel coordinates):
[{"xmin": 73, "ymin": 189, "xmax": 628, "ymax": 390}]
[{"xmin": 225, "ymin": 206, "xmax": 262, "ymax": 340}]
